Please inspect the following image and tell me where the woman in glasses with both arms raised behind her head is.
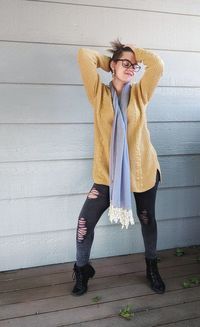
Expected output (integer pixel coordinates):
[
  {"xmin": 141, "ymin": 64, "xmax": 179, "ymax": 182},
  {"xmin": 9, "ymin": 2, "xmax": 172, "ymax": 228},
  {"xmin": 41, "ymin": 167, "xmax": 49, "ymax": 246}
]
[{"xmin": 72, "ymin": 40, "xmax": 165, "ymax": 295}]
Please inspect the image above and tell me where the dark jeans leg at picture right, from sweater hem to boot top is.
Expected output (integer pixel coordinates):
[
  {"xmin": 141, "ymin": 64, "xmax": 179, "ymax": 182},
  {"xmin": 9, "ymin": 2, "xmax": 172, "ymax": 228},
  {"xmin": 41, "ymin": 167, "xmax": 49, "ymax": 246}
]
[{"xmin": 134, "ymin": 171, "xmax": 160, "ymax": 259}]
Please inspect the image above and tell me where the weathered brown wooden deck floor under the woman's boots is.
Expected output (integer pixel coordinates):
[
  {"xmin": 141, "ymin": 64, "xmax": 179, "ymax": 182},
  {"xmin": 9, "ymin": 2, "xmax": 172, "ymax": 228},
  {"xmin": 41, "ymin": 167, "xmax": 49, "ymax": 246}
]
[{"xmin": 0, "ymin": 247, "xmax": 200, "ymax": 327}]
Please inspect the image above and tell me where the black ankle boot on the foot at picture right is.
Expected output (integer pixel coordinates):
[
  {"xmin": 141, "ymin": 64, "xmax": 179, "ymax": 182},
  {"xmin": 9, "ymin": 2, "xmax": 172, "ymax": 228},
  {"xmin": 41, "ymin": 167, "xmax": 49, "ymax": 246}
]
[{"xmin": 145, "ymin": 258, "xmax": 165, "ymax": 294}]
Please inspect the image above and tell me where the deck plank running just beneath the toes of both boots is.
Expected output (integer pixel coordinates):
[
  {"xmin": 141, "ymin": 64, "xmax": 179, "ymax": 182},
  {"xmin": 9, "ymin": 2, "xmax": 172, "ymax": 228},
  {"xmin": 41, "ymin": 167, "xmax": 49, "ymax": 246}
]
[{"xmin": 0, "ymin": 278, "xmax": 200, "ymax": 320}]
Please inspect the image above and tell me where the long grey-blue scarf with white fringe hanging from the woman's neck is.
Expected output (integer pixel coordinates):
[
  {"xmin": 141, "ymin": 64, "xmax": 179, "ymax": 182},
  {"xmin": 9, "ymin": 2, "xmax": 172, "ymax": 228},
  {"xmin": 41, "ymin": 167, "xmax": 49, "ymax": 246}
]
[{"xmin": 108, "ymin": 82, "xmax": 134, "ymax": 228}]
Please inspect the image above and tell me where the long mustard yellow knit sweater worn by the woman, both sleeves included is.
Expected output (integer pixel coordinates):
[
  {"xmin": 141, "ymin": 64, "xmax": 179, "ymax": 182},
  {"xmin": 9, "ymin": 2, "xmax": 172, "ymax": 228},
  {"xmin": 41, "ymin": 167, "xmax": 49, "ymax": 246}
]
[{"xmin": 78, "ymin": 45, "xmax": 163, "ymax": 192}]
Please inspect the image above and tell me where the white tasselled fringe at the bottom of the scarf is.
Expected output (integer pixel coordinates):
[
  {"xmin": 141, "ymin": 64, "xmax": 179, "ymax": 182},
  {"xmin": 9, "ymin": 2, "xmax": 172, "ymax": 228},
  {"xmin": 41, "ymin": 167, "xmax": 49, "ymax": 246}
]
[{"xmin": 108, "ymin": 204, "xmax": 135, "ymax": 229}]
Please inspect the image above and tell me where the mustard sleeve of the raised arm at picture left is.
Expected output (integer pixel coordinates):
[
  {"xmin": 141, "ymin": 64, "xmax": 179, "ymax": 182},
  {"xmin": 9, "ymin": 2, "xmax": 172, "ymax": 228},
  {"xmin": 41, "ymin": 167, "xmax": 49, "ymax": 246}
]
[{"xmin": 78, "ymin": 48, "xmax": 110, "ymax": 105}]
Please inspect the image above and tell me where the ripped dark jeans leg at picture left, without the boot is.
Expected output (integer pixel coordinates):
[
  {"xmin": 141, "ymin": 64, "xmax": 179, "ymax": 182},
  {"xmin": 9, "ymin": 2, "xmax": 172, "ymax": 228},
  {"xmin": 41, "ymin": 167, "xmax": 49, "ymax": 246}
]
[{"xmin": 76, "ymin": 183, "xmax": 109, "ymax": 267}]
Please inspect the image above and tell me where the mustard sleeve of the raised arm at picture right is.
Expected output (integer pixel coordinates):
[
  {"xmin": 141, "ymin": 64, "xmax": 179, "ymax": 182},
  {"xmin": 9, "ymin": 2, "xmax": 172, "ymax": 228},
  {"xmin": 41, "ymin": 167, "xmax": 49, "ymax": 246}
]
[{"xmin": 129, "ymin": 45, "xmax": 164, "ymax": 105}]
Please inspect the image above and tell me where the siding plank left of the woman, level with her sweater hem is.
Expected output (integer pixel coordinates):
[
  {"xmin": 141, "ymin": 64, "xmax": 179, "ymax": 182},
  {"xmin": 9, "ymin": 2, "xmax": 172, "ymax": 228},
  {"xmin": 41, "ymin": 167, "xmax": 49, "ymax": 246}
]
[{"xmin": 0, "ymin": 160, "xmax": 92, "ymax": 199}]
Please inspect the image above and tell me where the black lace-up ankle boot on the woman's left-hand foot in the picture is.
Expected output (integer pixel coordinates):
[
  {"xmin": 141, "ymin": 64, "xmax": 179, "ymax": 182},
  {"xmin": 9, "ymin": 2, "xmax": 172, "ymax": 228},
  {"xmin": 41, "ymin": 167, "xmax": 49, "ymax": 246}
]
[{"xmin": 72, "ymin": 263, "xmax": 95, "ymax": 295}]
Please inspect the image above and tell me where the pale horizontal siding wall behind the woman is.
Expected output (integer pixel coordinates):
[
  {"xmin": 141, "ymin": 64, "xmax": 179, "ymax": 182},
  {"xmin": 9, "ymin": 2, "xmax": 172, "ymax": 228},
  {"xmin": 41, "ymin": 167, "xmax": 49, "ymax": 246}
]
[{"xmin": 0, "ymin": 0, "xmax": 200, "ymax": 270}]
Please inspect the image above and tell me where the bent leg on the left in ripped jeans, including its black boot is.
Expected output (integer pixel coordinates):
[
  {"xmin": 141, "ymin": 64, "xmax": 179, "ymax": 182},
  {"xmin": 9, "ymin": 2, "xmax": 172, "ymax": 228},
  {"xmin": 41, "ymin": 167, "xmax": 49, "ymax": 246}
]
[{"xmin": 72, "ymin": 184, "xmax": 109, "ymax": 296}]
